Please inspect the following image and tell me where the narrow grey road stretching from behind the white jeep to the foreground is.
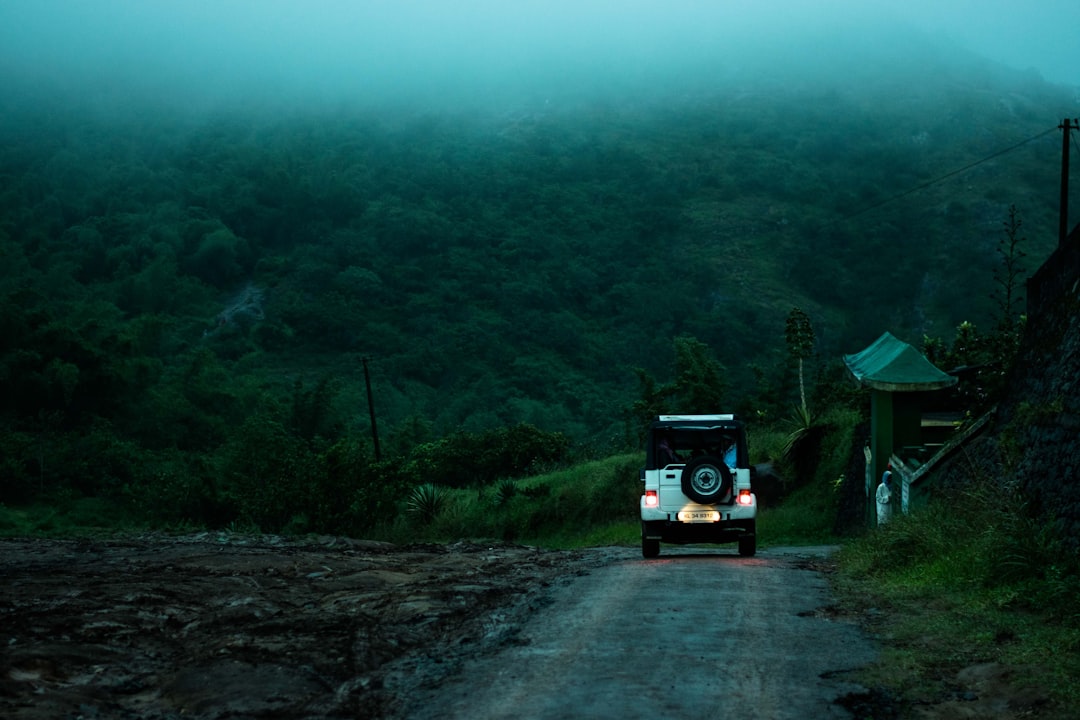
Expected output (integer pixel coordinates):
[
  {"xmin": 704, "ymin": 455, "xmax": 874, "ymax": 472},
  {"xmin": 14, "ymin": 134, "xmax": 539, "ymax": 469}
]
[{"xmin": 401, "ymin": 548, "xmax": 876, "ymax": 720}]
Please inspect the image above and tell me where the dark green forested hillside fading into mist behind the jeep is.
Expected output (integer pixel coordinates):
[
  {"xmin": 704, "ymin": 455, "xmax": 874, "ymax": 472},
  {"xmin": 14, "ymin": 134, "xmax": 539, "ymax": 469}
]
[{"xmin": 0, "ymin": 35, "xmax": 1076, "ymax": 496}]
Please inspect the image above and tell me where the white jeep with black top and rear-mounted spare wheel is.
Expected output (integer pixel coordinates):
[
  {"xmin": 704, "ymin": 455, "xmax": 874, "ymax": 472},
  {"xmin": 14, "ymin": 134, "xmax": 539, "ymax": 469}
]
[{"xmin": 642, "ymin": 415, "xmax": 757, "ymax": 557}]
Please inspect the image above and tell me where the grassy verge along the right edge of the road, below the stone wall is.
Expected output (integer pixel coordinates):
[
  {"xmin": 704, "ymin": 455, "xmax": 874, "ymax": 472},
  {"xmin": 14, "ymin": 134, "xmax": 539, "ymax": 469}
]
[{"xmin": 833, "ymin": 488, "xmax": 1080, "ymax": 717}]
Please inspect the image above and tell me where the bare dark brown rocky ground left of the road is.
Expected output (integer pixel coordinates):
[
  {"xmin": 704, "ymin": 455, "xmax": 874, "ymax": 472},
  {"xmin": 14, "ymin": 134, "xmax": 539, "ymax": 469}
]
[{"xmin": 0, "ymin": 533, "xmax": 606, "ymax": 720}]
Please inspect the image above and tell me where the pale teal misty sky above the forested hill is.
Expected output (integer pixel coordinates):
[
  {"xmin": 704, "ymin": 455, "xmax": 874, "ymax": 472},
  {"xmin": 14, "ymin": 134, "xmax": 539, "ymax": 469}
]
[{"xmin": 0, "ymin": 0, "xmax": 1080, "ymax": 117}]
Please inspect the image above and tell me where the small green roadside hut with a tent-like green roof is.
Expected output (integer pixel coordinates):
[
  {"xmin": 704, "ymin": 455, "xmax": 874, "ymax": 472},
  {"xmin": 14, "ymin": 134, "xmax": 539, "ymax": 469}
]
[{"xmin": 843, "ymin": 332, "xmax": 957, "ymax": 525}]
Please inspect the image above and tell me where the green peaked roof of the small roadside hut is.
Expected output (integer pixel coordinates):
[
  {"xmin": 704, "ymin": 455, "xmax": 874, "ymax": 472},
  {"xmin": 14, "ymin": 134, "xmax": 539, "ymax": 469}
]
[{"xmin": 843, "ymin": 332, "xmax": 957, "ymax": 393}]
